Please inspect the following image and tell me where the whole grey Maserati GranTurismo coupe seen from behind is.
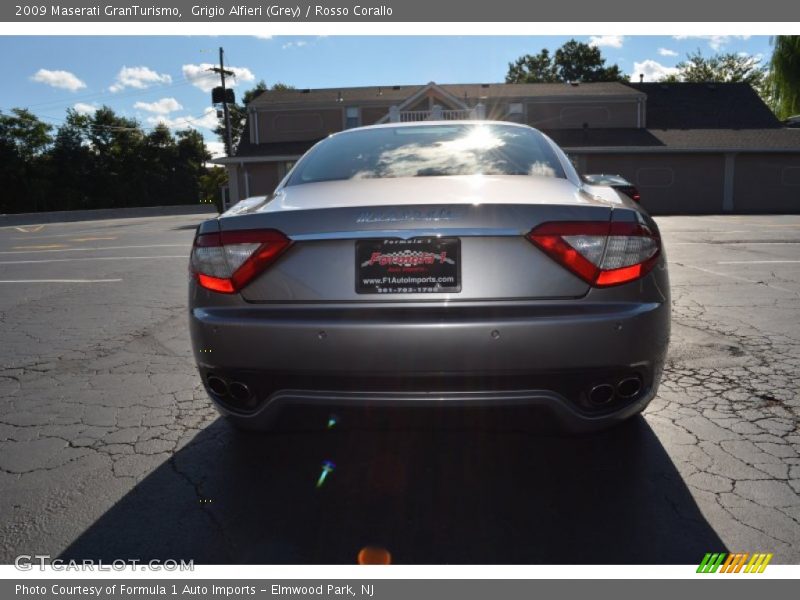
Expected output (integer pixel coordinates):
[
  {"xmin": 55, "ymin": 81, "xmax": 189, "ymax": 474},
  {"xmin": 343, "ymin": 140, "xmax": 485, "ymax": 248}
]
[{"xmin": 189, "ymin": 121, "xmax": 670, "ymax": 431}]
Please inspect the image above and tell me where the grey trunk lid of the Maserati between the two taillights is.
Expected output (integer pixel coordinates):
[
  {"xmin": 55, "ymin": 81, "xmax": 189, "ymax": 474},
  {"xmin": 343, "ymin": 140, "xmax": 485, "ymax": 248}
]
[{"xmin": 220, "ymin": 176, "xmax": 611, "ymax": 302}]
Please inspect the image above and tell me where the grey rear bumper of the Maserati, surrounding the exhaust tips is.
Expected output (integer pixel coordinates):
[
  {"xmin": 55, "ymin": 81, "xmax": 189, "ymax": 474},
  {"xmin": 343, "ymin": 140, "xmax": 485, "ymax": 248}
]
[{"xmin": 190, "ymin": 301, "xmax": 669, "ymax": 431}]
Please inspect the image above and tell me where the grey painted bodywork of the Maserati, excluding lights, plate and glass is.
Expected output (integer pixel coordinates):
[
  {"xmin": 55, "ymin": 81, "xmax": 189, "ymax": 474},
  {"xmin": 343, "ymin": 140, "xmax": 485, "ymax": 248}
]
[{"xmin": 190, "ymin": 123, "xmax": 670, "ymax": 430}]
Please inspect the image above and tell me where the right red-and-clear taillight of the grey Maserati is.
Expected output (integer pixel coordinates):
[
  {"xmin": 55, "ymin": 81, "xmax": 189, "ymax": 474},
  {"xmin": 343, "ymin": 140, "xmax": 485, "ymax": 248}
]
[{"xmin": 527, "ymin": 221, "xmax": 661, "ymax": 287}]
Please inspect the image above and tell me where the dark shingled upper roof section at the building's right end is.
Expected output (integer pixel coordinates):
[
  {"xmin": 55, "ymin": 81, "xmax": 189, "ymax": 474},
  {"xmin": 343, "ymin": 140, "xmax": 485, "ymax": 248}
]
[{"xmin": 628, "ymin": 82, "xmax": 781, "ymax": 129}]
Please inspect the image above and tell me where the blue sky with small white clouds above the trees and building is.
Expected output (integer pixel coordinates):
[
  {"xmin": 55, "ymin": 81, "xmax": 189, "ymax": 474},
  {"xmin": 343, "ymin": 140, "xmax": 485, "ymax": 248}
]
[{"xmin": 0, "ymin": 36, "xmax": 770, "ymax": 153}]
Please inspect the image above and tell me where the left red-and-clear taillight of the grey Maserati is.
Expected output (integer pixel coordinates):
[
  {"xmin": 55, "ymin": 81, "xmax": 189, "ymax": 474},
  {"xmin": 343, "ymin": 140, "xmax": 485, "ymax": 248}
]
[{"xmin": 191, "ymin": 229, "xmax": 292, "ymax": 294}]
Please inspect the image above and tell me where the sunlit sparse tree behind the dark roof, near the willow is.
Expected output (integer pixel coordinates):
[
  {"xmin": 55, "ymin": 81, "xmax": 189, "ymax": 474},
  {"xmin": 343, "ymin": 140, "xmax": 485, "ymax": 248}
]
[{"xmin": 661, "ymin": 50, "xmax": 767, "ymax": 97}]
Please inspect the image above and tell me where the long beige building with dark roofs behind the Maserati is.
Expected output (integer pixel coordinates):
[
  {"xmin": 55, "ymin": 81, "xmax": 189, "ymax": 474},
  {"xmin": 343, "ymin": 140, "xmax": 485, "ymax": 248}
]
[{"xmin": 215, "ymin": 83, "xmax": 800, "ymax": 214}]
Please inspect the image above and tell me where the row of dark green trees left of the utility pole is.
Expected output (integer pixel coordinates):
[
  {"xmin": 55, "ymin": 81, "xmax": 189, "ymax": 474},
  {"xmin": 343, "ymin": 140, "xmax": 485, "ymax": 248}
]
[{"xmin": 0, "ymin": 106, "xmax": 224, "ymax": 212}]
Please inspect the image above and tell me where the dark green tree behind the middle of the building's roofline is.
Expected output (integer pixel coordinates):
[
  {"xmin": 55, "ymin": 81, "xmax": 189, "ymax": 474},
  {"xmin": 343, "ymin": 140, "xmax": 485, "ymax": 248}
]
[{"xmin": 506, "ymin": 39, "xmax": 628, "ymax": 83}]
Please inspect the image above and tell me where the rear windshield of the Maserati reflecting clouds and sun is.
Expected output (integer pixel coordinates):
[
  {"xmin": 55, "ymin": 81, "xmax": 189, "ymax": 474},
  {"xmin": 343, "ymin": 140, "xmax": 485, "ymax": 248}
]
[{"xmin": 287, "ymin": 123, "xmax": 565, "ymax": 185}]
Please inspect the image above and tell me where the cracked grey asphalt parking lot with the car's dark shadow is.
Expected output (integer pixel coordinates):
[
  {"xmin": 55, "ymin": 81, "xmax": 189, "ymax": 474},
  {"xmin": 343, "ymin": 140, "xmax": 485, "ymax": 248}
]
[{"xmin": 0, "ymin": 216, "xmax": 800, "ymax": 564}]
